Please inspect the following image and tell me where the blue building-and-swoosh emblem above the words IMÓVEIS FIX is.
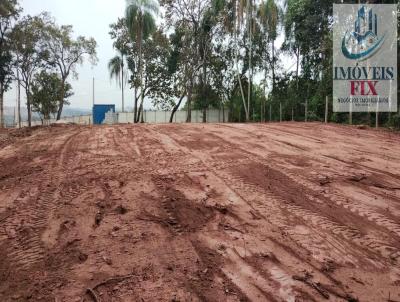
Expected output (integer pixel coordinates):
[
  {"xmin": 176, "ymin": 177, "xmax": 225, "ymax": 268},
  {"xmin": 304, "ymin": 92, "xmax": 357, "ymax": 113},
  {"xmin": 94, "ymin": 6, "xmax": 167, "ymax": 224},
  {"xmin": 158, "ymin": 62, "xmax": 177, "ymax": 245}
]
[{"xmin": 342, "ymin": 6, "xmax": 385, "ymax": 61}]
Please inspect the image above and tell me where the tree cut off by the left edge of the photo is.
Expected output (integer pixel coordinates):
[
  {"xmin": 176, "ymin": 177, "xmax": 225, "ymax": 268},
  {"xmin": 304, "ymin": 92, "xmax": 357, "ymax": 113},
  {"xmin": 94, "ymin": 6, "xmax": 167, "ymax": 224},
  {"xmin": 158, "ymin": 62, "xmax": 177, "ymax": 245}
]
[{"xmin": 0, "ymin": 0, "xmax": 20, "ymax": 128}]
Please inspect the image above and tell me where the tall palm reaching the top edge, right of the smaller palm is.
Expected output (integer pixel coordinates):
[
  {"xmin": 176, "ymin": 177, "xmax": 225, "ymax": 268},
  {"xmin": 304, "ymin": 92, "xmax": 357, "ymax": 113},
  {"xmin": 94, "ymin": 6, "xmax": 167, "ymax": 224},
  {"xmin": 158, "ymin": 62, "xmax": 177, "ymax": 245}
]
[{"xmin": 126, "ymin": 0, "xmax": 158, "ymax": 122}]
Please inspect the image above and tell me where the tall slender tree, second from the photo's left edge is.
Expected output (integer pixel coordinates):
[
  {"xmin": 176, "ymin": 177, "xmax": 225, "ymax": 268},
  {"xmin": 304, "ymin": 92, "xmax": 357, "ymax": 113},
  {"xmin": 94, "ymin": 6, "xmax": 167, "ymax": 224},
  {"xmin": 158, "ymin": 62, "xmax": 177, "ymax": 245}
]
[{"xmin": 11, "ymin": 14, "xmax": 49, "ymax": 127}]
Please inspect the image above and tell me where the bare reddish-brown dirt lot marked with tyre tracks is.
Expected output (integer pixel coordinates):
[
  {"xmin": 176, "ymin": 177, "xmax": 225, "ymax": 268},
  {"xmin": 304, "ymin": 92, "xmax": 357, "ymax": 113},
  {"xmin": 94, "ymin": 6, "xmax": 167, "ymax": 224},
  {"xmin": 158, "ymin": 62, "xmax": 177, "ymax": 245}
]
[{"xmin": 0, "ymin": 123, "xmax": 400, "ymax": 302}]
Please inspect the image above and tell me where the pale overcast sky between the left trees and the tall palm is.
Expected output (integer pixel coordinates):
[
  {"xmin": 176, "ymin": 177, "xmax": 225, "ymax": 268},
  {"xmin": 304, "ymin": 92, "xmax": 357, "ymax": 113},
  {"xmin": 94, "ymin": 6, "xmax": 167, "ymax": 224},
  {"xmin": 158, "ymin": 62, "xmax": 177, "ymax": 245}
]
[{"xmin": 5, "ymin": 0, "xmax": 136, "ymax": 109}]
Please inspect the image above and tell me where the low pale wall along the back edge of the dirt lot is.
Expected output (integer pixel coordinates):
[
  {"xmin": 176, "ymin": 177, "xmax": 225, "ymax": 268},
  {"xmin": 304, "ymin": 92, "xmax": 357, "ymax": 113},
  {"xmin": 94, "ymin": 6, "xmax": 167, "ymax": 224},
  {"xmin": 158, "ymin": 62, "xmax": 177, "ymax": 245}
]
[{"xmin": 17, "ymin": 109, "xmax": 228, "ymax": 127}]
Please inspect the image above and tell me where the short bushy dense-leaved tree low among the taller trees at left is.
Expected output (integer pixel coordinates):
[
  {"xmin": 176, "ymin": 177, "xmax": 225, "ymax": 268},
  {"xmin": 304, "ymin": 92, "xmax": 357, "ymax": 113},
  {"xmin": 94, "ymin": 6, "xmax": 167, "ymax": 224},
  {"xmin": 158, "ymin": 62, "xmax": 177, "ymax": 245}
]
[{"xmin": 31, "ymin": 70, "xmax": 73, "ymax": 123}]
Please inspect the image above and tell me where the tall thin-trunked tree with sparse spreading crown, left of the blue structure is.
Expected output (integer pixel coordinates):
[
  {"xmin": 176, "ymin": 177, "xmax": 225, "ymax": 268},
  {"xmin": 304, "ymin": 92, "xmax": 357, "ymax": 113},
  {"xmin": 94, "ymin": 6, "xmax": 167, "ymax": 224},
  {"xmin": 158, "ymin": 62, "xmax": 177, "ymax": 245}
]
[{"xmin": 43, "ymin": 22, "xmax": 98, "ymax": 120}]
